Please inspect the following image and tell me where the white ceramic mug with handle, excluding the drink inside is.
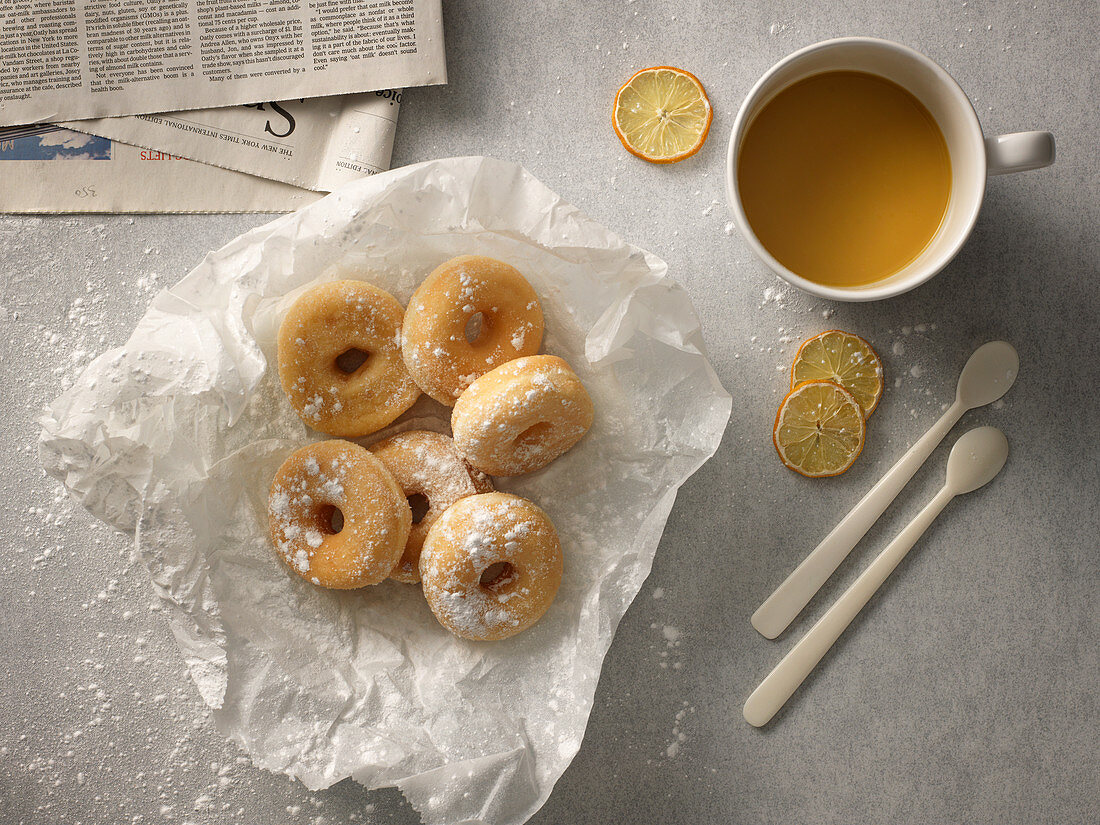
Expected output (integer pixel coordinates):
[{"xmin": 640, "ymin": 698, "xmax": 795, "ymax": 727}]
[{"xmin": 726, "ymin": 37, "xmax": 1054, "ymax": 301}]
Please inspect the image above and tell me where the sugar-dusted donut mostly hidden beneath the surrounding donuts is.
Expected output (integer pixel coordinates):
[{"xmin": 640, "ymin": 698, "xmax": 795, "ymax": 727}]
[{"xmin": 369, "ymin": 430, "xmax": 493, "ymax": 584}]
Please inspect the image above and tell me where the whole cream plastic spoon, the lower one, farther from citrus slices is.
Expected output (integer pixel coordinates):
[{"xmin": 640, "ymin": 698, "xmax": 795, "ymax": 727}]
[{"xmin": 745, "ymin": 427, "xmax": 1009, "ymax": 727}]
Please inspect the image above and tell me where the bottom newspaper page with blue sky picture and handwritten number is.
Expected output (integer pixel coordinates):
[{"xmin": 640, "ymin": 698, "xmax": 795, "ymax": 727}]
[{"xmin": 0, "ymin": 125, "xmax": 321, "ymax": 213}]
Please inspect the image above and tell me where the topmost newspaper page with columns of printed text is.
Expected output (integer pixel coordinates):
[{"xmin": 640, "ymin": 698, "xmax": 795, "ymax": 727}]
[{"xmin": 0, "ymin": 0, "xmax": 447, "ymax": 125}]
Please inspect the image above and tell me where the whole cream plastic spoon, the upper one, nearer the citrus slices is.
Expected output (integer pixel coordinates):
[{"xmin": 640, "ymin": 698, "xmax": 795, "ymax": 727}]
[{"xmin": 751, "ymin": 341, "xmax": 1020, "ymax": 639}]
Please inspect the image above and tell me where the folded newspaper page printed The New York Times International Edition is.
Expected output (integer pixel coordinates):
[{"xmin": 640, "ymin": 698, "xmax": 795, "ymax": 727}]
[{"xmin": 63, "ymin": 89, "xmax": 402, "ymax": 191}]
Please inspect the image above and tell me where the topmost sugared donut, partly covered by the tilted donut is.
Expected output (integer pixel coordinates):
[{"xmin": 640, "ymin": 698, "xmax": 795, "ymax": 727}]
[{"xmin": 402, "ymin": 255, "xmax": 542, "ymax": 407}]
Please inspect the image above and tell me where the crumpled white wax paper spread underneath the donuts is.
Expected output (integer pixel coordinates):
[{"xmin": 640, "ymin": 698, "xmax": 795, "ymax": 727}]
[{"xmin": 41, "ymin": 157, "xmax": 730, "ymax": 825}]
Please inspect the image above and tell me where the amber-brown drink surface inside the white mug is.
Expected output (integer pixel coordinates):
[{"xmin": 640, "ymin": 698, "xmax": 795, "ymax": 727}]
[{"xmin": 737, "ymin": 72, "xmax": 952, "ymax": 287}]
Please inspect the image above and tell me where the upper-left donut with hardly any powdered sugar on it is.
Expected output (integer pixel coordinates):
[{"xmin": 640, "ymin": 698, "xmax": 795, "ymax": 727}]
[{"xmin": 278, "ymin": 281, "xmax": 420, "ymax": 438}]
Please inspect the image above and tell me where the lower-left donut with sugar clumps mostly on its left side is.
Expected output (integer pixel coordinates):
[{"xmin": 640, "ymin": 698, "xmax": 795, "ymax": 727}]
[{"xmin": 267, "ymin": 440, "xmax": 413, "ymax": 590}]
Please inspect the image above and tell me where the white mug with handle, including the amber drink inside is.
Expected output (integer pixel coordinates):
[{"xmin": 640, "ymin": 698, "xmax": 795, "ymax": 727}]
[{"xmin": 726, "ymin": 37, "xmax": 1054, "ymax": 300}]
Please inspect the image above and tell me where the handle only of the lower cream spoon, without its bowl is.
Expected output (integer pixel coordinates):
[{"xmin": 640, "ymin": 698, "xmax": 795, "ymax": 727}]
[{"xmin": 745, "ymin": 487, "xmax": 955, "ymax": 727}]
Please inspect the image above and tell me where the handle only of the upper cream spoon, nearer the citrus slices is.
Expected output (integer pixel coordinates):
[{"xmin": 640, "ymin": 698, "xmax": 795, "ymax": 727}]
[{"xmin": 751, "ymin": 399, "xmax": 966, "ymax": 639}]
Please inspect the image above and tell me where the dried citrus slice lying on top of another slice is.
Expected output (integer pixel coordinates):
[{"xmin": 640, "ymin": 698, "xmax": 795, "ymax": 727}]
[{"xmin": 771, "ymin": 381, "xmax": 867, "ymax": 479}]
